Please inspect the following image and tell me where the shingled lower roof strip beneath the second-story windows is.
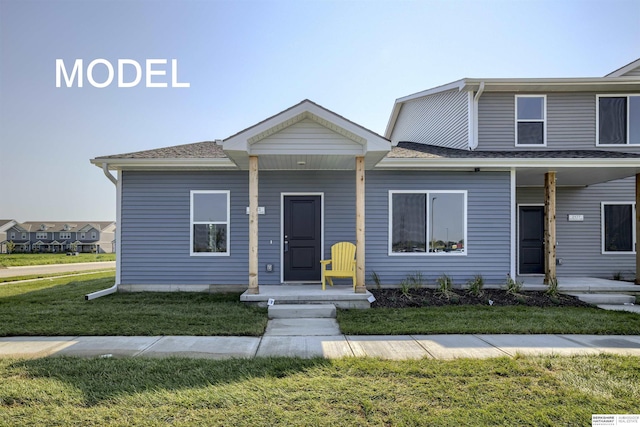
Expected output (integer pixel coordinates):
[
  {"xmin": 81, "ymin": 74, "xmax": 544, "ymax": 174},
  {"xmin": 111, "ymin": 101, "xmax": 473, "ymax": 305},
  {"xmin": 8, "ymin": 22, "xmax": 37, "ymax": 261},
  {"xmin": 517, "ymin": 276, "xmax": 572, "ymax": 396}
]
[{"xmin": 387, "ymin": 142, "xmax": 640, "ymax": 159}]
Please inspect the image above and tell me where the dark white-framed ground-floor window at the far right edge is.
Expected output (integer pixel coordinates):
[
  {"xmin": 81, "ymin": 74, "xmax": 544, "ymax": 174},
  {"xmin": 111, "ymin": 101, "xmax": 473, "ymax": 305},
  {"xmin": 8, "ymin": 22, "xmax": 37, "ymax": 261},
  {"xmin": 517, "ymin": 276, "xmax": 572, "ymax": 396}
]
[{"xmin": 602, "ymin": 202, "xmax": 636, "ymax": 253}]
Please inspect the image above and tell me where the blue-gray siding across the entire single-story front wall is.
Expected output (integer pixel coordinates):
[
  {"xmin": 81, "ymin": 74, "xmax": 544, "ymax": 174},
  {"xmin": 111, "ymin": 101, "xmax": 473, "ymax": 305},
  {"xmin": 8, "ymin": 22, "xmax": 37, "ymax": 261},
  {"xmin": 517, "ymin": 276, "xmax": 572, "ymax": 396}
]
[{"xmin": 120, "ymin": 171, "xmax": 510, "ymax": 285}]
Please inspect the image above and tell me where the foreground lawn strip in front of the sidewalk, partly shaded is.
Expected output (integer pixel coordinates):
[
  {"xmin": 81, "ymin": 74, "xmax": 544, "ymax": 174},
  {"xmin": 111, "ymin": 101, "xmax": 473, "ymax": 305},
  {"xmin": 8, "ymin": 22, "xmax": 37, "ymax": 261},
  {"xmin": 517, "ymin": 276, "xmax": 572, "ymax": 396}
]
[{"xmin": 0, "ymin": 355, "xmax": 640, "ymax": 426}]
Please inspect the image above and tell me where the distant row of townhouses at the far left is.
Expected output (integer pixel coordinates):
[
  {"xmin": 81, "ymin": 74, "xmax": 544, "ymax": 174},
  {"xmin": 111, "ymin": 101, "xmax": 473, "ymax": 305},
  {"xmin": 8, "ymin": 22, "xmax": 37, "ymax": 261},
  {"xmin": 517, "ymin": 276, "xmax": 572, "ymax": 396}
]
[{"xmin": 2, "ymin": 221, "xmax": 115, "ymax": 253}]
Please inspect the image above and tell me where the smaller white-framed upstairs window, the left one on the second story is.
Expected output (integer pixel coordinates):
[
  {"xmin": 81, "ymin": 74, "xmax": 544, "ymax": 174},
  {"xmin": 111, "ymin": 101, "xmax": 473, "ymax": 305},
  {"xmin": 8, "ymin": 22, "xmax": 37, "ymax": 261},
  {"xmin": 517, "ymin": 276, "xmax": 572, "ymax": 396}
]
[{"xmin": 516, "ymin": 95, "xmax": 547, "ymax": 146}]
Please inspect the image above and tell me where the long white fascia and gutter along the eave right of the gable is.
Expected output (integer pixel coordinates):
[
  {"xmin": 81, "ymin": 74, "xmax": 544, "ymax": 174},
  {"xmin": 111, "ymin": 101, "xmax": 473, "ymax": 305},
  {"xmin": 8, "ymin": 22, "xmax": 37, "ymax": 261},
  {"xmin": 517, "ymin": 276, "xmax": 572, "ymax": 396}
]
[{"xmin": 376, "ymin": 158, "xmax": 640, "ymax": 172}]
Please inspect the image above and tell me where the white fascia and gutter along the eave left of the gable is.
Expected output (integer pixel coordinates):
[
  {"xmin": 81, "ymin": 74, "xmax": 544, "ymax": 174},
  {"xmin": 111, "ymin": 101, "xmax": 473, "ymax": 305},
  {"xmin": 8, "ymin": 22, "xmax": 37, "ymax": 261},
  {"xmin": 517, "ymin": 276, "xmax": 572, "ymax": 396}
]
[{"xmin": 90, "ymin": 158, "xmax": 238, "ymax": 170}]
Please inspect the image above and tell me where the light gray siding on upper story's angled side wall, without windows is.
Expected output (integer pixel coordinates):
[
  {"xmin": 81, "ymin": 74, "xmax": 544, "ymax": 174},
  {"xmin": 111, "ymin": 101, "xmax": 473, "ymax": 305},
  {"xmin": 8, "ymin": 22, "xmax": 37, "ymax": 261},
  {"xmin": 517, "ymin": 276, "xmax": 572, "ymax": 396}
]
[{"xmin": 391, "ymin": 89, "xmax": 469, "ymax": 149}]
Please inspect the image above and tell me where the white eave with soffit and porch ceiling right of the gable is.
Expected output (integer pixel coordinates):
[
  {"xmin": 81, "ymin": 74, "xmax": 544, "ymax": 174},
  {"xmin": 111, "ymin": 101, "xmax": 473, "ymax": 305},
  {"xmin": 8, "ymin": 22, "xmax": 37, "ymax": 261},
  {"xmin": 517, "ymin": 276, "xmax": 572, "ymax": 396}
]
[{"xmin": 375, "ymin": 158, "xmax": 640, "ymax": 186}]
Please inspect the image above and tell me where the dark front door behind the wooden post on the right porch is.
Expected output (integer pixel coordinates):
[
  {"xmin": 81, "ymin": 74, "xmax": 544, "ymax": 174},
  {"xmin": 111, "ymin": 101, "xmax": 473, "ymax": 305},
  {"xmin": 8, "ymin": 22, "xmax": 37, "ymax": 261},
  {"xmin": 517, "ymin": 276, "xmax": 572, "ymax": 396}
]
[{"xmin": 518, "ymin": 206, "xmax": 544, "ymax": 274}]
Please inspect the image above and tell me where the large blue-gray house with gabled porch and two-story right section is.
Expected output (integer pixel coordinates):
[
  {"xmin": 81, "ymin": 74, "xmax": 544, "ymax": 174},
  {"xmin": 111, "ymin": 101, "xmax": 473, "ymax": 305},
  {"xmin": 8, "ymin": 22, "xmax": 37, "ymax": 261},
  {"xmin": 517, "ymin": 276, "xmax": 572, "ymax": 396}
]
[{"xmin": 91, "ymin": 60, "xmax": 640, "ymax": 293}]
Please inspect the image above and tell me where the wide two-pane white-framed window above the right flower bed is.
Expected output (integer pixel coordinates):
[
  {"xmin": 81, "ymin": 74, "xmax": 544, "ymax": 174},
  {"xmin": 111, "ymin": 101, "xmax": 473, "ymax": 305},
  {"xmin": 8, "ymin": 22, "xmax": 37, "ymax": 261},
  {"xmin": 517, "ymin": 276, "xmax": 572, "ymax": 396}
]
[{"xmin": 389, "ymin": 191, "xmax": 467, "ymax": 255}]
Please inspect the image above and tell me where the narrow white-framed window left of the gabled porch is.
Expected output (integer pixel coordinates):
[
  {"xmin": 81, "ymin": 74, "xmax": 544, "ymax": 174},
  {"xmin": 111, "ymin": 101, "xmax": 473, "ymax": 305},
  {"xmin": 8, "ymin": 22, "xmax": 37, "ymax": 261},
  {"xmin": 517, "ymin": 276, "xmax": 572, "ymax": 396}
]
[{"xmin": 191, "ymin": 190, "xmax": 229, "ymax": 255}]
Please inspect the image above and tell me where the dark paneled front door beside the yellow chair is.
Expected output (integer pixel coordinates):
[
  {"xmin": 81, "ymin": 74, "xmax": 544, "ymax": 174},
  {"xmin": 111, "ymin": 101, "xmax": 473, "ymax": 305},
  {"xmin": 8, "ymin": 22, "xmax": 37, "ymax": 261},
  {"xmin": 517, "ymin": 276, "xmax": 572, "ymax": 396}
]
[{"xmin": 282, "ymin": 196, "xmax": 322, "ymax": 282}]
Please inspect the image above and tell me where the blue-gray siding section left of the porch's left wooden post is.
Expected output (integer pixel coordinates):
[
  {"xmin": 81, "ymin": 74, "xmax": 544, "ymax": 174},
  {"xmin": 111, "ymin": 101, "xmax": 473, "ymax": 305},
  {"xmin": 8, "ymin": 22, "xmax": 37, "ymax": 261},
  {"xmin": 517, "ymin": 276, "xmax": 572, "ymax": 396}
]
[{"xmin": 118, "ymin": 172, "xmax": 249, "ymax": 285}]
